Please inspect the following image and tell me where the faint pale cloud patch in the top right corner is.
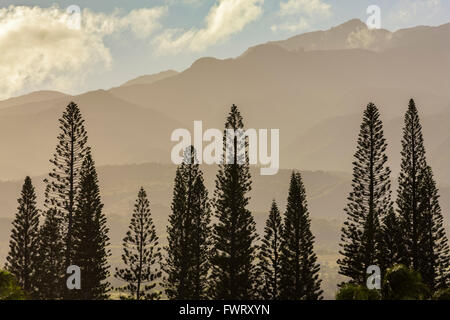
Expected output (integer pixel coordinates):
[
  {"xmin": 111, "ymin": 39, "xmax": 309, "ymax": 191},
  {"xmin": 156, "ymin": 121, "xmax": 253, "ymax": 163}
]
[{"xmin": 388, "ymin": 0, "xmax": 442, "ymax": 27}]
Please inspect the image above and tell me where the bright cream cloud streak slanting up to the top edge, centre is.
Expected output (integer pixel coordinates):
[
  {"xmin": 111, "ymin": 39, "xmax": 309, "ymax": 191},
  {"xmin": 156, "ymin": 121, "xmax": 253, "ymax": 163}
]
[{"xmin": 155, "ymin": 0, "xmax": 264, "ymax": 54}]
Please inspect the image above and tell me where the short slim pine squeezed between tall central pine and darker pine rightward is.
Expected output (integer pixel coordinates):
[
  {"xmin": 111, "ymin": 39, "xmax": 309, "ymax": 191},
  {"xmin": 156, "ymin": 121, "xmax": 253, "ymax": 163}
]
[{"xmin": 258, "ymin": 200, "xmax": 283, "ymax": 300}]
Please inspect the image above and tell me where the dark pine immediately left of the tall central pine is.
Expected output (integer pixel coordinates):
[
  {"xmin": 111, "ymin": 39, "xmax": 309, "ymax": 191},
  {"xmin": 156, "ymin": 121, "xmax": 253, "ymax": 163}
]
[{"xmin": 164, "ymin": 146, "xmax": 211, "ymax": 300}]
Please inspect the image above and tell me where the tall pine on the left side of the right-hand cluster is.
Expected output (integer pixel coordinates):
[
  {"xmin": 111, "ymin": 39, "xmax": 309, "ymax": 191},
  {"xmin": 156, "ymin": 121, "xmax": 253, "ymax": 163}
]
[{"xmin": 338, "ymin": 103, "xmax": 392, "ymax": 284}]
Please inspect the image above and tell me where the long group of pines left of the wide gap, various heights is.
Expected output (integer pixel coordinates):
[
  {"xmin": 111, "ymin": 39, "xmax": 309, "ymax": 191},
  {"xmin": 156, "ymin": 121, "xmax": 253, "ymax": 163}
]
[{"xmin": 6, "ymin": 103, "xmax": 322, "ymax": 300}]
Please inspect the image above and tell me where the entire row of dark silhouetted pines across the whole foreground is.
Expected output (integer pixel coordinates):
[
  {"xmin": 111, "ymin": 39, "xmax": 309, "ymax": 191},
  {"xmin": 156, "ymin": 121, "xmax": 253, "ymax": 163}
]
[{"xmin": 6, "ymin": 100, "xmax": 450, "ymax": 300}]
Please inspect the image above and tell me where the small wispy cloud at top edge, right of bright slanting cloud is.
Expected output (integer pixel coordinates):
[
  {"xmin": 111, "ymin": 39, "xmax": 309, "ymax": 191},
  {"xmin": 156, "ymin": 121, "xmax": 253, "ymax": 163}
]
[{"xmin": 271, "ymin": 0, "xmax": 331, "ymax": 32}]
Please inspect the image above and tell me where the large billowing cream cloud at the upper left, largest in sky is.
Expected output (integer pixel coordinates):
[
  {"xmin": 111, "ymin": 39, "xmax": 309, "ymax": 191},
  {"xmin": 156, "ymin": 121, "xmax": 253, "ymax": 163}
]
[{"xmin": 0, "ymin": 6, "xmax": 166, "ymax": 99}]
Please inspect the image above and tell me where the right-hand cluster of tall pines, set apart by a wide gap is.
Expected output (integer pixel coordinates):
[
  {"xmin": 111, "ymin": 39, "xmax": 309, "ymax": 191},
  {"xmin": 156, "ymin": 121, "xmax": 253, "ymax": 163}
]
[{"xmin": 338, "ymin": 100, "xmax": 450, "ymax": 294}]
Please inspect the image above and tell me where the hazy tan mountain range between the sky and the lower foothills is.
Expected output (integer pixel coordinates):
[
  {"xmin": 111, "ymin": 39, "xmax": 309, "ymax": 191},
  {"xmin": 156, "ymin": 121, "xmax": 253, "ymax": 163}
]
[{"xmin": 0, "ymin": 20, "xmax": 450, "ymax": 185}]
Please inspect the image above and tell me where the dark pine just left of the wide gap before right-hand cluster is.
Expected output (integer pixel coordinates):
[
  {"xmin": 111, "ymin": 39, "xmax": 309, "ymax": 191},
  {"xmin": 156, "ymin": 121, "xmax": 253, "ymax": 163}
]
[{"xmin": 281, "ymin": 172, "xmax": 322, "ymax": 300}]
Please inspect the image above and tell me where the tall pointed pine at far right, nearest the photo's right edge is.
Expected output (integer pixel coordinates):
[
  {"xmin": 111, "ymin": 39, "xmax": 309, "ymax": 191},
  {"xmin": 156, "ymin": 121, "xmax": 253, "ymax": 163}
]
[{"xmin": 397, "ymin": 99, "xmax": 450, "ymax": 292}]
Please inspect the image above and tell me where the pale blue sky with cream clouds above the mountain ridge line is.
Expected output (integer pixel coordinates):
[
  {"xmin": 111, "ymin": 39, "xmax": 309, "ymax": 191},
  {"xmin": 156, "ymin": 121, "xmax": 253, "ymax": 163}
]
[{"xmin": 0, "ymin": 0, "xmax": 450, "ymax": 99}]
